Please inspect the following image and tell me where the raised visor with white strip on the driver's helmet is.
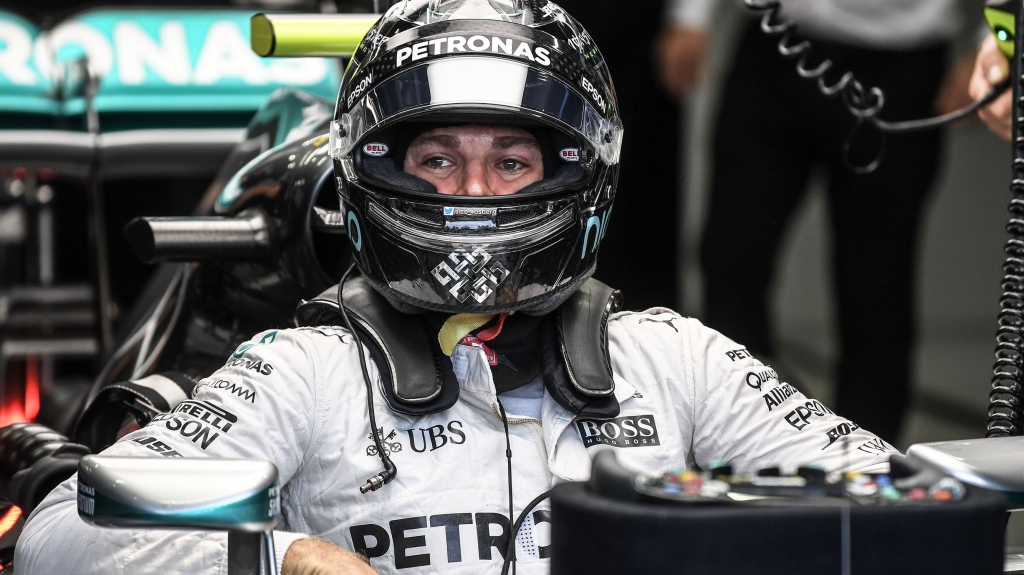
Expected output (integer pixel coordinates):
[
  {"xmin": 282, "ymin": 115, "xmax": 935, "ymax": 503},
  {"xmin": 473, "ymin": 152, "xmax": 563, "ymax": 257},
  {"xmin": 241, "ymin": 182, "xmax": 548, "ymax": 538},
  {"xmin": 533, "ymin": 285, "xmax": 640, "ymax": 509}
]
[{"xmin": 330, "ymin": 56, "xmax": 623, "ymax": 165}]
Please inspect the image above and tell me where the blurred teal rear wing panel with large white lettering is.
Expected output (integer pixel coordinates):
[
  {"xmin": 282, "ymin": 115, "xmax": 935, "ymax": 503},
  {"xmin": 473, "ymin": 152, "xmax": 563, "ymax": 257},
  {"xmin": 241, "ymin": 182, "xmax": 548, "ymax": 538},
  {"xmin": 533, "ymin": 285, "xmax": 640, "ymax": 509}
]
[{"xmin": 0, "ymin": 8, "xmax": 341, "ymax": 131}]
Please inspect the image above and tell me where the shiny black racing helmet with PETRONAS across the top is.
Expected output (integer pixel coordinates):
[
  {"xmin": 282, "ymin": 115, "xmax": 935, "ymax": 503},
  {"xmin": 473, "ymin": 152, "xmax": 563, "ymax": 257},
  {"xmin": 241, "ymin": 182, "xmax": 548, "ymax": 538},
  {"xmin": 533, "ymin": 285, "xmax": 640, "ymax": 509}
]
[{"xmin": 330, "ymin": 0, "xmax": 623, "ymax": 313}]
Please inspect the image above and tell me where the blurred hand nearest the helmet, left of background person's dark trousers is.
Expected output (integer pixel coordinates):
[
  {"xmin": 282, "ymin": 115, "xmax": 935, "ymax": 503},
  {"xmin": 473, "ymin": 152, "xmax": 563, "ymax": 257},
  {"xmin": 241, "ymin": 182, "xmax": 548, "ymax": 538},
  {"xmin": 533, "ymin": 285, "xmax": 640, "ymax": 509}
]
[{"xmin": 654, "ymin": 26, "xmax": 708, "ymax": 99}]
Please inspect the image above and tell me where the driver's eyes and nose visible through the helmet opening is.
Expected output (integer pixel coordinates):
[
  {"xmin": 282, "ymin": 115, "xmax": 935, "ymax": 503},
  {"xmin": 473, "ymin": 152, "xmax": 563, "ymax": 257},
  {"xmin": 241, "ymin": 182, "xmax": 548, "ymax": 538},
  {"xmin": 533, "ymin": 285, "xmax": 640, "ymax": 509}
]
[{"xmin": 402, "ymin": 124, "xmax": 544, "ymax": 195}]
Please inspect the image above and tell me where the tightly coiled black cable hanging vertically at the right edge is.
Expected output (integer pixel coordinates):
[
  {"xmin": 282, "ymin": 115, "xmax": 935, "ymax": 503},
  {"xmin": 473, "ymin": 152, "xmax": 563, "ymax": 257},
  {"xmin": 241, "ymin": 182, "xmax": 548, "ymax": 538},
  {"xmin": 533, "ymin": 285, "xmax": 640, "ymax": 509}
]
[{"xmin": 985, "ymin": 3, "xmax": 1024, "ymax": 437}]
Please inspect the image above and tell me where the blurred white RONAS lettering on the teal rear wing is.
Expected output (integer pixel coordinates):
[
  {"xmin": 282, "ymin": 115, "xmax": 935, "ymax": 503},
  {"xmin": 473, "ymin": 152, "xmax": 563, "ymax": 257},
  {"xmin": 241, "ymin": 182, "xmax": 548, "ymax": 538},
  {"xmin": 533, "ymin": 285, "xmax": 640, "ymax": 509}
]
[{"xmin": 0, "ymin": 12, "xmax": 330, "ymax": 86}]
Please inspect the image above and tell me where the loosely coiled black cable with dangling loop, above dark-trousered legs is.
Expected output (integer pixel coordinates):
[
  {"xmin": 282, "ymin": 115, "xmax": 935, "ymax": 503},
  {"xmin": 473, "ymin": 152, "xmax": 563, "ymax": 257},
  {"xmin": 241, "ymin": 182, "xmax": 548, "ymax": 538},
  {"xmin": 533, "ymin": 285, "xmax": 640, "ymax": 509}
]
[{"xmin": 743, "ymin": 0, "xmax": 1011, "ymax": 174}]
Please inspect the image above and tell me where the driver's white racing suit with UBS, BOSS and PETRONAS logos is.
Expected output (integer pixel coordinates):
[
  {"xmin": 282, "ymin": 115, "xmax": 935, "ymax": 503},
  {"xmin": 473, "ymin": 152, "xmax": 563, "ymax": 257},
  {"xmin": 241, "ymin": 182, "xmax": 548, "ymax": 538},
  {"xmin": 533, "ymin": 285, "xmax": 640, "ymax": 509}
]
[{"xmin": 15, "ymin": 309, "xmax": 894, "ymax": 575}]
